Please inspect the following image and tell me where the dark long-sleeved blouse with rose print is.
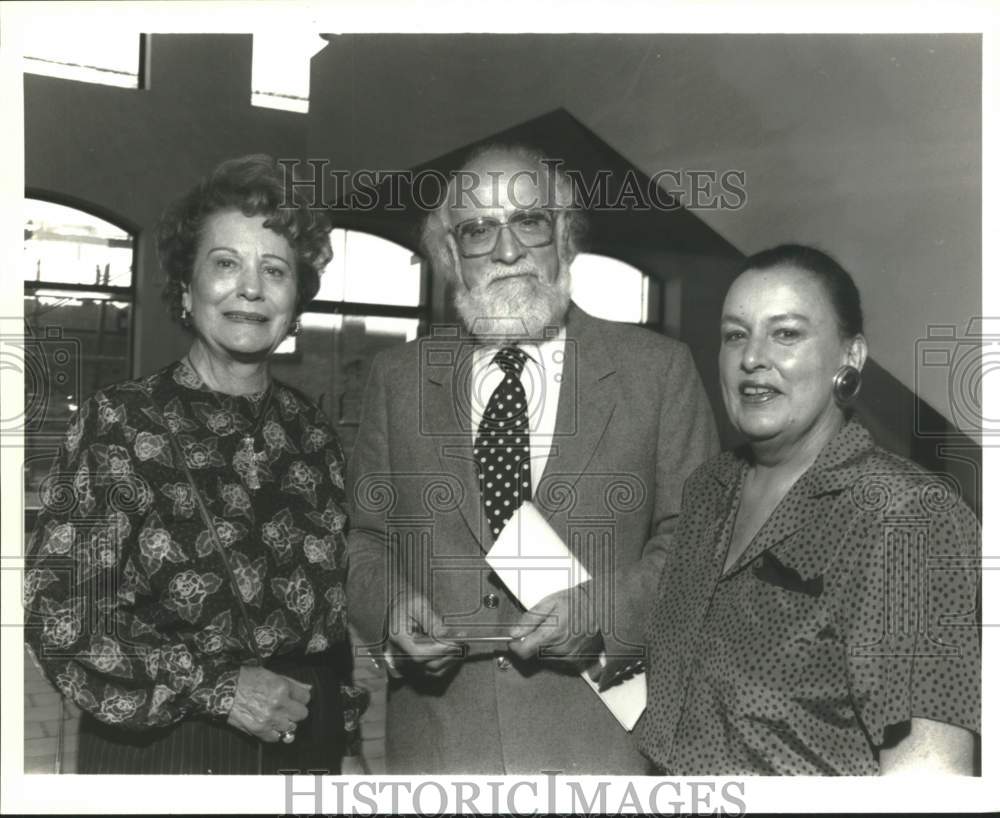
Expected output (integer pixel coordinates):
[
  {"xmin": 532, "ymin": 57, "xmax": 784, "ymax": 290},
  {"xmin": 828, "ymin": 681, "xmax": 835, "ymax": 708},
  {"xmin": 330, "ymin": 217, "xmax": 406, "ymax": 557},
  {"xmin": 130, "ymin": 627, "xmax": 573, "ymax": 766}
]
[{"xmin": 25, "ymin": 361, "xmax": 360, "ymax": 730}]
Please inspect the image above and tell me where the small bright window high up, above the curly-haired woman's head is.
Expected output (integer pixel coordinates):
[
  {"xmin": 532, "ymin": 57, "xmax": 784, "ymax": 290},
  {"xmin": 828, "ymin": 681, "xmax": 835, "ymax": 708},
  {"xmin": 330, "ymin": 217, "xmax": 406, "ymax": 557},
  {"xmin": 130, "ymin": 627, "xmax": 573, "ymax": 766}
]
[{"xmin": 250, "ymin": 31, "xmax": 326, "ymax": 114}]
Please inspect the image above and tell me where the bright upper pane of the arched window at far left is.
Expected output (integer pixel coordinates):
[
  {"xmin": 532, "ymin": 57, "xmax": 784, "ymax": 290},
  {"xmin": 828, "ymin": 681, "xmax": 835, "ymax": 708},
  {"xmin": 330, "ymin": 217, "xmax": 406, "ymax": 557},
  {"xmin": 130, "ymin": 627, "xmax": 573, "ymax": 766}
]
[{"xmin": 21, "ymin": 199, "xmax": 133, "ymax": 287}]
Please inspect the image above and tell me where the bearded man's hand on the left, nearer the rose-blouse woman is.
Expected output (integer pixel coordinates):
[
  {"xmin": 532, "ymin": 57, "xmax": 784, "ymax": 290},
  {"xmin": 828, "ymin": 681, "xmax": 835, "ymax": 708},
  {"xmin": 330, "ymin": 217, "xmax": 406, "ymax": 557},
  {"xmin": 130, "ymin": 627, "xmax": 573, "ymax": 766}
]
[{"xmin": 386, "ymin": 590, "xmax": 462, "ymax": 678}]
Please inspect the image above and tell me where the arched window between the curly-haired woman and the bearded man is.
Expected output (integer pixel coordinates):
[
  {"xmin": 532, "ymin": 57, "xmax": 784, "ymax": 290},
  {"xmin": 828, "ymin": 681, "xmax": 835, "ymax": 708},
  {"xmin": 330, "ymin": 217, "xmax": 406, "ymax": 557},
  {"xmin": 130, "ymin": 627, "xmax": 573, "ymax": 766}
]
[{"xmin": 272, "ymin": 228, "xmax": 430, "ymax": 450}]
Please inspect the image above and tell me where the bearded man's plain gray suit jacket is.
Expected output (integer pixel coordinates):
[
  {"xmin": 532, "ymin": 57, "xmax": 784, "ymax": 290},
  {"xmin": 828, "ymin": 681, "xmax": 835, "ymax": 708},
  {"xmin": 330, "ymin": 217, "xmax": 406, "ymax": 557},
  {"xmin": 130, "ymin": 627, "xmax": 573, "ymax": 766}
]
[{"xmin": 348, "ymin": 306, "xmax": 718, "ymax": 774}]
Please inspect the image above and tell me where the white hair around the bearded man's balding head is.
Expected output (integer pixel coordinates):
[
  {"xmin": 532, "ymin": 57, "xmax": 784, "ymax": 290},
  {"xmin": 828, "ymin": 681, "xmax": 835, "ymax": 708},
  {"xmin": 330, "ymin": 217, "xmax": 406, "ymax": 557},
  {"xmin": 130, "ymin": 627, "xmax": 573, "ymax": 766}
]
[{"xmin": 420, "ymin": 142, "xmax": 587, "ymax": 280}]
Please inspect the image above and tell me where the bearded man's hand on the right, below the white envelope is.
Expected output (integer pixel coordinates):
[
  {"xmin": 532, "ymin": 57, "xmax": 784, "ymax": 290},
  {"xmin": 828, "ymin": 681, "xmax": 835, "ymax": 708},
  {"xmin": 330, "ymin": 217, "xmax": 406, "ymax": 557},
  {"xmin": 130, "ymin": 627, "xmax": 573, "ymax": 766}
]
[{"xmin": 510, "ymin": 583, "xmax": 603, "ymax": 674}]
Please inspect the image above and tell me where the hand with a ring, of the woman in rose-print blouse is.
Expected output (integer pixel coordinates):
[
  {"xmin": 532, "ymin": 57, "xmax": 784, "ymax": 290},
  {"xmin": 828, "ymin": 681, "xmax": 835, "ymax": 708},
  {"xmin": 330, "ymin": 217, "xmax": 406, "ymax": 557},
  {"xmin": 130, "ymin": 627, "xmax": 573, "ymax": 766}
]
[{"xmin": 228, "ymin": 665, "xmax": 312, "ymax": 743}]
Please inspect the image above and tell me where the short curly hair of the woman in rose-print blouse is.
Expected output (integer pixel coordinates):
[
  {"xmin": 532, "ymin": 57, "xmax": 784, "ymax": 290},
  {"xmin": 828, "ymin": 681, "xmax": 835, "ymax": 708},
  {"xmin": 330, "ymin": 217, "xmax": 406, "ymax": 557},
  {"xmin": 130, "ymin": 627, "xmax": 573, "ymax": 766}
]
[{"xmin": 156, "ymin": 153, "xmax": 333, "ymax": 321}]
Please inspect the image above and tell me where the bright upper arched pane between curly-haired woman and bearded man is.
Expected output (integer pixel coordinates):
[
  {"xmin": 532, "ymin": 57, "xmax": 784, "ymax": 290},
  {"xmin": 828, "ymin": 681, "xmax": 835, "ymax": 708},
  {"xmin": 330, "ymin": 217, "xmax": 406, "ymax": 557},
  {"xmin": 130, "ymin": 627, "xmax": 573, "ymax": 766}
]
[{"xmin": 316, "ymin": 229, "xmax": 420, "ymax": 307}]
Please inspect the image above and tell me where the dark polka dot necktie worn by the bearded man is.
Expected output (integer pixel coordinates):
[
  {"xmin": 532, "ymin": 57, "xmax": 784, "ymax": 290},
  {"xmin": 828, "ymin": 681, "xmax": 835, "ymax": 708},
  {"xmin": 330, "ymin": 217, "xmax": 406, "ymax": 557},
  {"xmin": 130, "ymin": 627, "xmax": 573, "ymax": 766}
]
[{"xmin": 472, "ymin": 347, "xmax": 531, "ymax": 538}]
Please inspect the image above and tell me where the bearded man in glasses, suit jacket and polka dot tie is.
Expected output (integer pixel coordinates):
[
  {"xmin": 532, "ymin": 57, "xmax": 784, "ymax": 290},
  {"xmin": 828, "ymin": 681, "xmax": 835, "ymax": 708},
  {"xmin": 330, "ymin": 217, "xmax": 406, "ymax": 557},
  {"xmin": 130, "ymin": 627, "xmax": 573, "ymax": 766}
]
[{"xmin": 348, "ymin": 147, "xmax": 718, "ymax": 774}]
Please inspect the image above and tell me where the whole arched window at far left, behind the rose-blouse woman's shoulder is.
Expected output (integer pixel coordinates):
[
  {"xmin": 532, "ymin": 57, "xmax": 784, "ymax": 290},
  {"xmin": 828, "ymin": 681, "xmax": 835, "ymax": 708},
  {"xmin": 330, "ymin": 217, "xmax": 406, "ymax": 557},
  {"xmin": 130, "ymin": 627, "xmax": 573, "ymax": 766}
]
[{"xmin": 22, "ymin": 198, "xmax": 135, "ymax": 508}]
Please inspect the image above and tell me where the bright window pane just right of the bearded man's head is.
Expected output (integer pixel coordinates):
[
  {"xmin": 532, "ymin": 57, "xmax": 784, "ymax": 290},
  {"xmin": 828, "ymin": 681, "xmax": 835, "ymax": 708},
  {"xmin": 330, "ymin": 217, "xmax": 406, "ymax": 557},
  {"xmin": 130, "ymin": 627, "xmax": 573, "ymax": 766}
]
[{"xmin": 571, "ymin": 253, "xmax": 649, "ymax": 324}]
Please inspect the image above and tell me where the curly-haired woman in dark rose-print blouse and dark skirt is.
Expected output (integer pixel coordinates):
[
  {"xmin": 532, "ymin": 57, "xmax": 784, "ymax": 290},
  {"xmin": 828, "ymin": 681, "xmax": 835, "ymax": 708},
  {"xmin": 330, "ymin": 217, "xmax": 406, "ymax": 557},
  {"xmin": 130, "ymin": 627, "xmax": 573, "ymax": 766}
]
[{"xmin": 25, "ymin": 156, "xmax": 362, "ymax": 774}]
